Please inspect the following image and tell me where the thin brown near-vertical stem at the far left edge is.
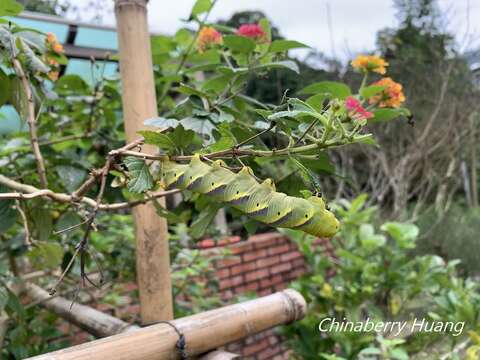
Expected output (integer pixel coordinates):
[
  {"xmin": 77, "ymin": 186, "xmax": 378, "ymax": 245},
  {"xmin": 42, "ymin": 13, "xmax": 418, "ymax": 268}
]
[{"xmin": 13, "ymin": 59, "xmax": 48, "ymax": 189}]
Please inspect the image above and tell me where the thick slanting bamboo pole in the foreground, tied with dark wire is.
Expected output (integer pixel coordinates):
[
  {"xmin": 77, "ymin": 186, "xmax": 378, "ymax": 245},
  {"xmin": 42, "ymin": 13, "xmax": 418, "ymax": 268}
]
[{"xmin": 26, "ymin": 289, "xmax": 306, "ymax": 360}]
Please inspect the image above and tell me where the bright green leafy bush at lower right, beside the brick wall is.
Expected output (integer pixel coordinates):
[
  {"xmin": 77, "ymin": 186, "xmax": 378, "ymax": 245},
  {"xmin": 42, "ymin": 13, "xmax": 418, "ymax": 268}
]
[{"xmin": 283, "ymin": 195, "xmax": 480, "ymax": 359}]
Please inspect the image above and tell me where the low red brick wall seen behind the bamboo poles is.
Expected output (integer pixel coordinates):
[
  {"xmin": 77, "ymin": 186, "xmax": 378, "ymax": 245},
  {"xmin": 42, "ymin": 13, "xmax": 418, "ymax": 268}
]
[{"xmin": 50, "ymin": 233, "xmax": 332, "ymax": 360}]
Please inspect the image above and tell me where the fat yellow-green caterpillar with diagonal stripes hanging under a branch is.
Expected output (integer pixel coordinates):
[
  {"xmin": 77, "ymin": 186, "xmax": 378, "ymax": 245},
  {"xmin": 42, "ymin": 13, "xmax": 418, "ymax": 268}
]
[{"xmin": 161, "ymin": 155, "xmax": 339, "ymax": 237}]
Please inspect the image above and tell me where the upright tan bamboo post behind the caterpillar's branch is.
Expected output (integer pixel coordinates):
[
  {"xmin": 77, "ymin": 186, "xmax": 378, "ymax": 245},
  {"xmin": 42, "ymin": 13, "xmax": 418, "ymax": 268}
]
[{"xmin": 115, "ymin": 0, "xmax": 173, "ymax": 324}]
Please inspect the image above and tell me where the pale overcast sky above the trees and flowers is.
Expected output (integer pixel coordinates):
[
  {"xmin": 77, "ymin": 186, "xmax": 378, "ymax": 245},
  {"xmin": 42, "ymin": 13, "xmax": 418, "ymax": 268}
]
[{"xmin": 76, "ymin": 0, "xmax": 480, "ymax": 60}]
